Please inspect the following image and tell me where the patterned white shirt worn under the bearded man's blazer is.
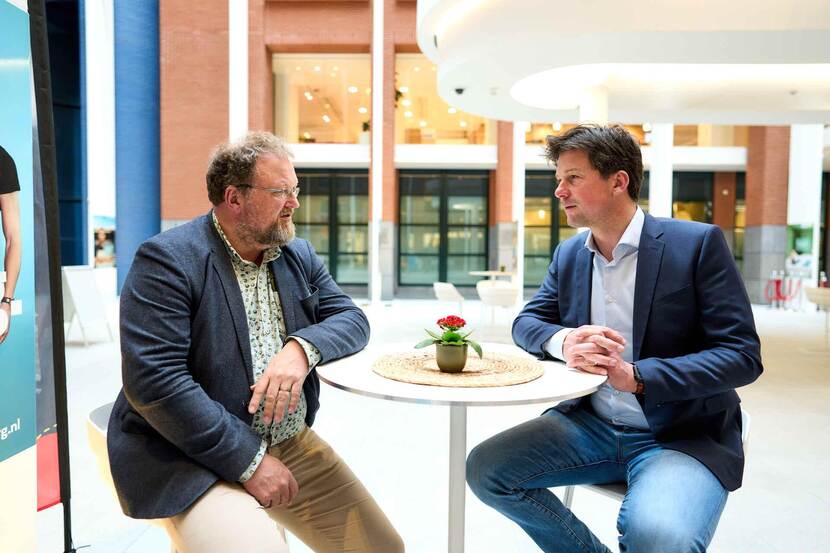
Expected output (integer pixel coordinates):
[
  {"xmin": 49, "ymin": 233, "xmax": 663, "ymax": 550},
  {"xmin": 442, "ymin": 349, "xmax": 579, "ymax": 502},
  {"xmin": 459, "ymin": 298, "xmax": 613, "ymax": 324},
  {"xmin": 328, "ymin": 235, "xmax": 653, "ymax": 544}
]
[{"xmin": 211, "ymin": 213, "xmax": 321, "ymax": 483}]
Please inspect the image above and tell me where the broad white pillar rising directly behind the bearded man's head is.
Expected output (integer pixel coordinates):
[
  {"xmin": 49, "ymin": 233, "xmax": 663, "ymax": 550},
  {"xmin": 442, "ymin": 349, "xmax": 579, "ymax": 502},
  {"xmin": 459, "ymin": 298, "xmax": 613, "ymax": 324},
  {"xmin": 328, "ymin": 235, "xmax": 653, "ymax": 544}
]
[{"xmin": 228, "ymin": 0, "xmax": 248, "ymax": 140}]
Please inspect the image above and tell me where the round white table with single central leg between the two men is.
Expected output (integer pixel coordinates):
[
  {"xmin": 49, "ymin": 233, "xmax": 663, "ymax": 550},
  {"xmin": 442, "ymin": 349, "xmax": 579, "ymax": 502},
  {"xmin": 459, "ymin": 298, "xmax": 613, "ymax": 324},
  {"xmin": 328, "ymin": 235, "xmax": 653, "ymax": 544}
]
[{"xmin": 317, "ymin": 343, "xmax": 605, "ymax": 553}]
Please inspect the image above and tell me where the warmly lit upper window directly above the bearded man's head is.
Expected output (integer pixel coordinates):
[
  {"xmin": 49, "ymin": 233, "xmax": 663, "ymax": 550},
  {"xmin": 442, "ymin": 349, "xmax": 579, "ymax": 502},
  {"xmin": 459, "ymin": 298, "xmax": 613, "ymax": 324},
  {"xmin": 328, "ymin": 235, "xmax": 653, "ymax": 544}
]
[{"xmin": 272, "ymin": 54, "xmax": 372, "ymax": 144}]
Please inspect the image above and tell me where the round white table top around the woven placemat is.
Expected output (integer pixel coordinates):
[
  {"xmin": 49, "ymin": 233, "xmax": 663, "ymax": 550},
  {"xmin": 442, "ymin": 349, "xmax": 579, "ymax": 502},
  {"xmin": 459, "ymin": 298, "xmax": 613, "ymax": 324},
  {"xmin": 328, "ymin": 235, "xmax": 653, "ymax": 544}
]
[{"xmin": 317, "ymin": 343, "xmax": 605, "ymax": 406}]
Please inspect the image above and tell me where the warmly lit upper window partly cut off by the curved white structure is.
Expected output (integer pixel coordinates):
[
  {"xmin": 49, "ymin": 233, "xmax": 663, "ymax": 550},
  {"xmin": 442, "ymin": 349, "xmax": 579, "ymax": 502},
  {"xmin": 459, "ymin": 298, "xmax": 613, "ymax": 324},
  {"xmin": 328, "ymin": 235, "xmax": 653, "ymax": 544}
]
[{"xmin": 395, "ymin": 54, "xmax": 496, "ymax": 144}]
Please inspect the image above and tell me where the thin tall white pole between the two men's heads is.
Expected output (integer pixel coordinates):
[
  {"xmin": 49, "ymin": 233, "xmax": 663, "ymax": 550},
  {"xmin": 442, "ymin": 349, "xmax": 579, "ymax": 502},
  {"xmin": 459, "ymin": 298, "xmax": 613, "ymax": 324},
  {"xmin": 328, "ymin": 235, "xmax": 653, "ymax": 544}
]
[{"xmin": 369, "ymin": 0, "xmax": 384, "ymax": 304}]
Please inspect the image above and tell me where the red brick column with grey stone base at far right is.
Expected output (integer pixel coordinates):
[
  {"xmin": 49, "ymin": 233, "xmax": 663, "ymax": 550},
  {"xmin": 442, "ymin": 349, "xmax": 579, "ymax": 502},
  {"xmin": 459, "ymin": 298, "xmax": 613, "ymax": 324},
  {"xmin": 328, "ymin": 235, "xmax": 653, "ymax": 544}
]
[{"xmin": 744, "ymin": 127, "xmax": 790, "ymax": 303}]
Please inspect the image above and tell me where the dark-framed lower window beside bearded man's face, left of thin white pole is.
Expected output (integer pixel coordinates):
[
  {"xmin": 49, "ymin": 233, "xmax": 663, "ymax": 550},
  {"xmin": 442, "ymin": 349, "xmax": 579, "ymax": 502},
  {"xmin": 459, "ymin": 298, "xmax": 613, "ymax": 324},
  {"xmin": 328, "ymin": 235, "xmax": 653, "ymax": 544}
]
[{"xmin": 295, "ymin": 169, "xmax": 369, "ymax": 284}]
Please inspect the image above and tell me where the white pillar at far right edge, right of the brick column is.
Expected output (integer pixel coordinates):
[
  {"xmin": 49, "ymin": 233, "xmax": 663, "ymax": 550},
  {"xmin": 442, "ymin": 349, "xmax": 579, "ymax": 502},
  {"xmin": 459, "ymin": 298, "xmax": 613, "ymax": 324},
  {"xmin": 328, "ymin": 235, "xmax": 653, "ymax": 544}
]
[{"xmin": 787, "ymin": 124, "xmax": 824, "ymax": 284}]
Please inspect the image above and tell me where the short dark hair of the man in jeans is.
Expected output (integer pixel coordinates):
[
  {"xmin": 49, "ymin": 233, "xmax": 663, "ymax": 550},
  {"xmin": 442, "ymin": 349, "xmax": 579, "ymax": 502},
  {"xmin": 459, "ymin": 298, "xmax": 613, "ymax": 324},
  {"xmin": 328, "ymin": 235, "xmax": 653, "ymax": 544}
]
[{"xmin": 545, "ymin": 125, "xmax": 643, "ymax": 202}]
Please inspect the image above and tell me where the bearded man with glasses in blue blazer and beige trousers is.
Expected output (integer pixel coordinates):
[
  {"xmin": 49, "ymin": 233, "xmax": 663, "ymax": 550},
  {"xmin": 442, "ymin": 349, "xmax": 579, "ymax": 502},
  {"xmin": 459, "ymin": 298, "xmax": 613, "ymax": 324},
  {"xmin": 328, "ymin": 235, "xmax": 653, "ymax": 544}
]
[{"xmin": 107, "ymin": 133, "xmax": 403, "ymax": 553}]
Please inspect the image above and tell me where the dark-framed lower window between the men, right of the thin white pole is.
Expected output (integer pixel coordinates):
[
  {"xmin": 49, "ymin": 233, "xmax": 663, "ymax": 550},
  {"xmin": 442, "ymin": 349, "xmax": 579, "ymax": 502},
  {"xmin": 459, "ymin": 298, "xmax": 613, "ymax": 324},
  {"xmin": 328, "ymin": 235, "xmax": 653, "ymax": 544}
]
[{"xmin": 398, "ymin": 171, "xmax": 489, "ymax": 285}]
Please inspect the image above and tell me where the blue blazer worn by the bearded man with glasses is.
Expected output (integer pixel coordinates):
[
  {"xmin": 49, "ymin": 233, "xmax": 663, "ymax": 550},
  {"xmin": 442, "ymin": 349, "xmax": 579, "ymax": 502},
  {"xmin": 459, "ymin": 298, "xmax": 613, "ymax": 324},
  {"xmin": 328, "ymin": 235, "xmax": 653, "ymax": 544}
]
[{"xmin": 107, "ymin": 214, "xmax": 369, "ymax": 518}]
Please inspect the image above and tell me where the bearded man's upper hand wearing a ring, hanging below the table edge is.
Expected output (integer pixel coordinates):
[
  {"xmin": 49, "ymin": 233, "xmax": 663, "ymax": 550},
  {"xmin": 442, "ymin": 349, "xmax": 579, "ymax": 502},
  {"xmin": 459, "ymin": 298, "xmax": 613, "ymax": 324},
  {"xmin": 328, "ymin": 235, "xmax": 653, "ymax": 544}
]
[{"xmin": 248, "ymin": 340, "xmax": 308, "ymax": 424}]
